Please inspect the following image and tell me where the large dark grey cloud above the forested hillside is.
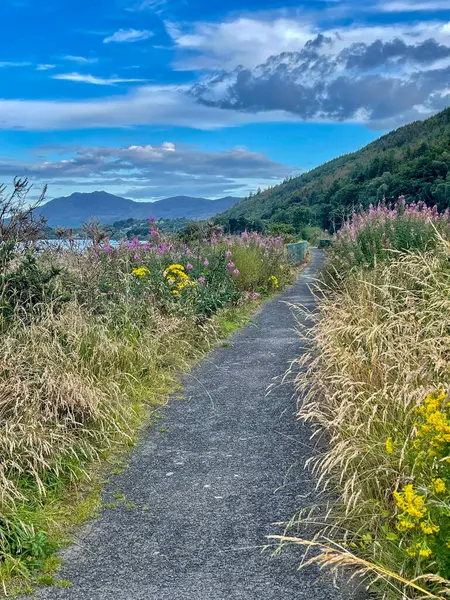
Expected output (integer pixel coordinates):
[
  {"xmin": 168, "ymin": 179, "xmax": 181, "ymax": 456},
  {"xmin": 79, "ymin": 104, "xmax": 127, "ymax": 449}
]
[{"xmin": 191, "ymin": 36, "xmax": 450, "ymax": 125}]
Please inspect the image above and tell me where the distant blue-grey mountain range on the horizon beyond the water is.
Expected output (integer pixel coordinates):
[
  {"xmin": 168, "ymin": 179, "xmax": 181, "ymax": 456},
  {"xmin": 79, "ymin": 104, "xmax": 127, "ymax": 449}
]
[{"xmin": 36, "ymin": 192, "xmax": 240, "ymax": 227}]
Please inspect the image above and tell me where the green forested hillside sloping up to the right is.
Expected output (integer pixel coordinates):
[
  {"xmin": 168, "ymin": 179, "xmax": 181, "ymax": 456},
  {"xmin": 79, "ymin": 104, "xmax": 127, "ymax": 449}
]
[{"xmin": 217, "ymin": 108, "xmax": 450, "ymax": 231}]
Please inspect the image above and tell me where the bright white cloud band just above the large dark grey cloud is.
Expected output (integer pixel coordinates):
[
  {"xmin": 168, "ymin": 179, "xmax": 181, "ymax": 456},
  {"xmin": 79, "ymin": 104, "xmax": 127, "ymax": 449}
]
[{"xmin": 166, "ymin": 14, "xmax": 448, "ymax": 70}]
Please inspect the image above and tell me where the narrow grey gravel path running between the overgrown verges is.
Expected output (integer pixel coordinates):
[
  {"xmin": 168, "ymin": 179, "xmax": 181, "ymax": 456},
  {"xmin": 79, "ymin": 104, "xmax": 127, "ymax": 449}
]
[{"xmin": 30, "ymin": 251, "xmax": 348, "ymax": 600}]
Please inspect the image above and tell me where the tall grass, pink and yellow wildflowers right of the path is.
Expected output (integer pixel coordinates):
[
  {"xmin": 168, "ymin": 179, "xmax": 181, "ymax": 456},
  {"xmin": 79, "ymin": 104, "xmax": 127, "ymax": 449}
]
[{"xmin": 274, "ymin": 198, "xmax": 450, "ymax": 600}]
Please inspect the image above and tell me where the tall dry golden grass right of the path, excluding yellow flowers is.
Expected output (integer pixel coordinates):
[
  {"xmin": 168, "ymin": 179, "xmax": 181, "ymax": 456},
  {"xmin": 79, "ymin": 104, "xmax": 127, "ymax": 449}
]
[{"xmin": 286, "ymin": 242, "xmax": 450, "ymax": 599}]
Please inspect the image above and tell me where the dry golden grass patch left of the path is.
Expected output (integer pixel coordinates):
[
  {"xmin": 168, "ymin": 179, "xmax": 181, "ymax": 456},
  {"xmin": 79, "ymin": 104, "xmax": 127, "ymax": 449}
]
[{"xmin": 0, "ymin": 303, "xmax": 216, "ymax": 506}]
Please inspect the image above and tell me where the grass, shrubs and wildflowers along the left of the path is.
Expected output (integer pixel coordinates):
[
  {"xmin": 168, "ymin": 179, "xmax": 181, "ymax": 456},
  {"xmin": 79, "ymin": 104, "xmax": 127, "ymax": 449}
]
[{"xmin": 0, "ymin": 180, "xmax": 293, "ymax": 594}]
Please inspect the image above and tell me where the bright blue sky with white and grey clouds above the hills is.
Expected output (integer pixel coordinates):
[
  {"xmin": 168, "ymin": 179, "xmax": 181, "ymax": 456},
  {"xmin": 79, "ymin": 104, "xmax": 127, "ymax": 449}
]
[{"xmin": 0, "ymin": 0, "xmax": 450, "ymax": 200}]
